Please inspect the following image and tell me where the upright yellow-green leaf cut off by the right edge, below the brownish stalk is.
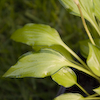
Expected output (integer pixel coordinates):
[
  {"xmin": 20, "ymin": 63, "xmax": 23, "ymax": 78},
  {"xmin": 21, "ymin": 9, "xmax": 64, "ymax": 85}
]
[{"xmin": 87, "ymin": 43, "xmax": 100, "ymax": 76}]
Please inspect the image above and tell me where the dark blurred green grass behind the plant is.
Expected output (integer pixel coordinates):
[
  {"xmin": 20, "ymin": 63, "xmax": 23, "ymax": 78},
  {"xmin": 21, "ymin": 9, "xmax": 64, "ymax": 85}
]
[{"xmin": 0, "ymin": 0, "xmax": 94, "ymax": 100}]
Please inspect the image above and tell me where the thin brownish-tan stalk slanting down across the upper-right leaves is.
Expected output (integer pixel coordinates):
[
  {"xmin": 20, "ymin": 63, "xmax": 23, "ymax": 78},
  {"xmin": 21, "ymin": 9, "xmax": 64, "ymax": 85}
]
[{"xmin": 74, "ymin": 0, "xmax": 95, "ymax": 45}]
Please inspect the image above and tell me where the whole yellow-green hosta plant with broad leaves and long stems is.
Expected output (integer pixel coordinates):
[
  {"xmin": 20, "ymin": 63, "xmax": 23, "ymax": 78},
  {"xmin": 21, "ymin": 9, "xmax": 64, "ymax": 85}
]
[{"xmin": 3, "ymin": 0, "xmax": 100, "ymax": 100}]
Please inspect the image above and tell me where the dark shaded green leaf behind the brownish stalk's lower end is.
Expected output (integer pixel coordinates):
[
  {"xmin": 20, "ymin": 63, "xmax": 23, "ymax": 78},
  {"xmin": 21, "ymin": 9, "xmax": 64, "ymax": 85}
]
[{"xmin": 79, "ymin": 39, "xmax": 100, "ymax": 58}]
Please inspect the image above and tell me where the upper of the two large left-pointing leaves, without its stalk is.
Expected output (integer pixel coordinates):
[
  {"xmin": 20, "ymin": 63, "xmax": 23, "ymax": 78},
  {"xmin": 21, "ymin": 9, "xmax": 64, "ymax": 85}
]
[{"xmin": 11, "ymin": 23, "xmax": 62, "ymax": 46}]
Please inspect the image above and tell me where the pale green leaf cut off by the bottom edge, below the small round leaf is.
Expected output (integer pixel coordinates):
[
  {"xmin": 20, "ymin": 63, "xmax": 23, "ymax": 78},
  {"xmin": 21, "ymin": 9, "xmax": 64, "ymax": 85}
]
[{"xmin": 54, "ymin": 93, "xmax": 85, "ymax": 100}]
